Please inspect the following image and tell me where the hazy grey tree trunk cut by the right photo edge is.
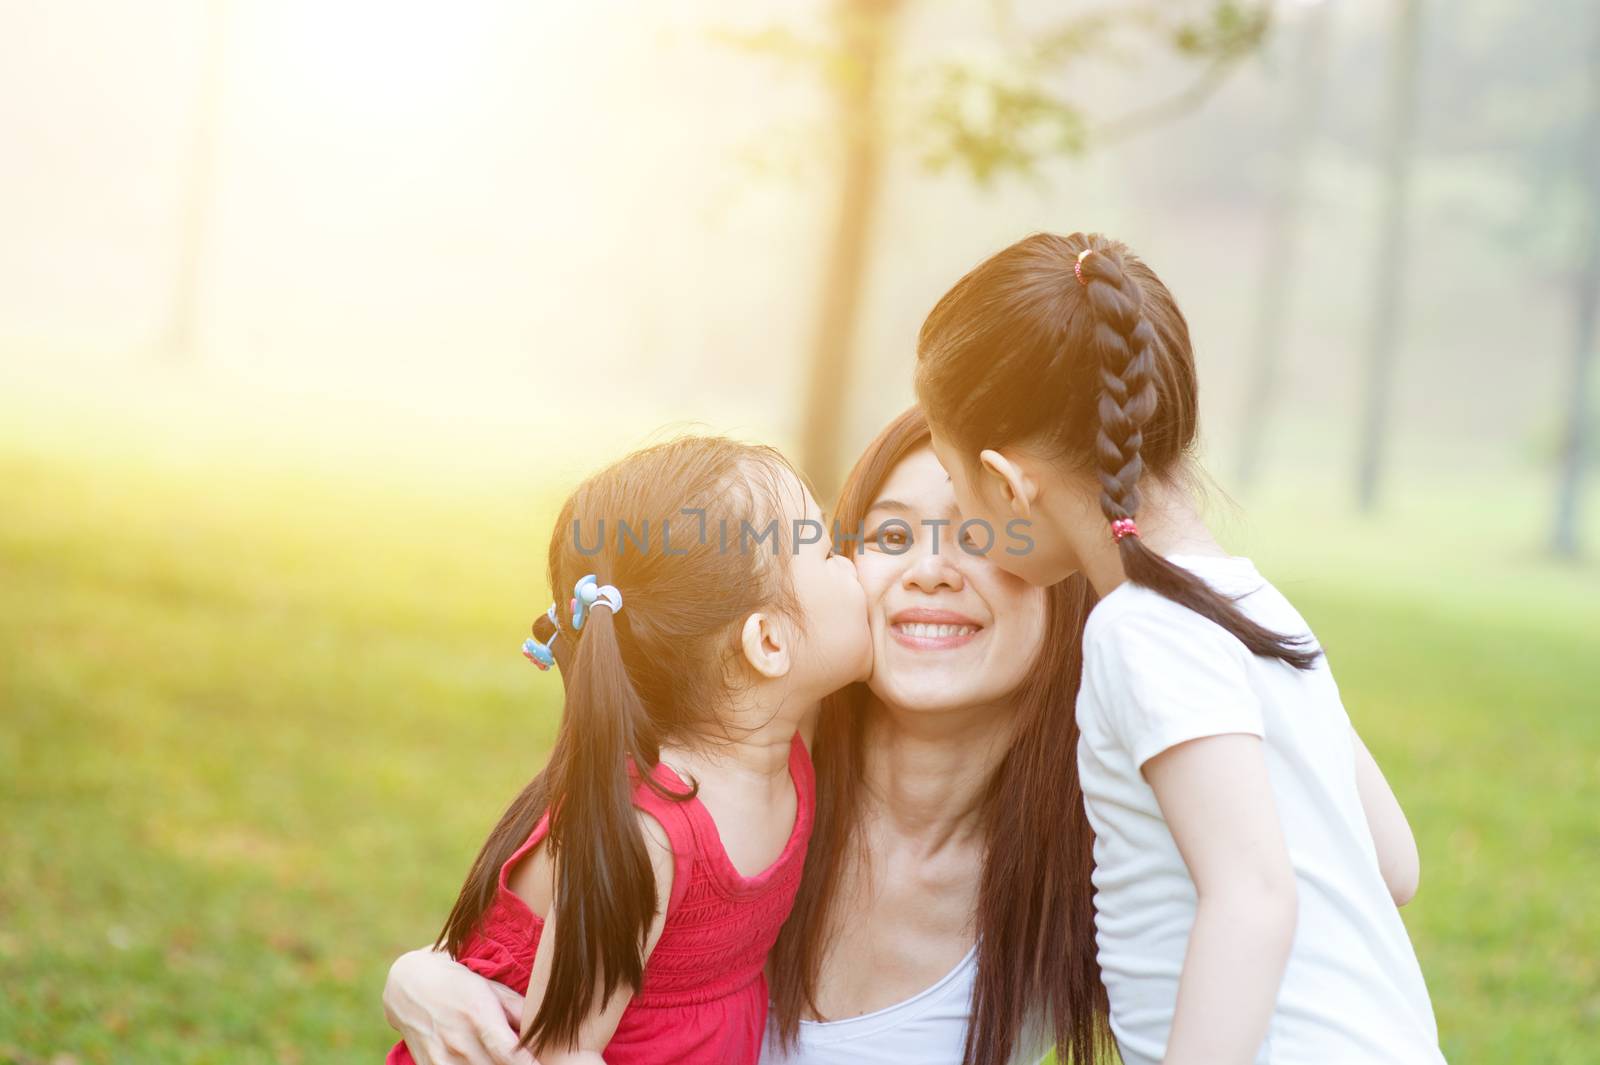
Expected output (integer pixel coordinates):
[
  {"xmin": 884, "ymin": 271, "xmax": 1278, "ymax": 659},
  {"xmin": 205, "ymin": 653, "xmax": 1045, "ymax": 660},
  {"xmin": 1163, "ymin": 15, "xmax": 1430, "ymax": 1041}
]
[{"xmin": 1554, "ymin": 12, "xmax": 1600, "ymax": 558}]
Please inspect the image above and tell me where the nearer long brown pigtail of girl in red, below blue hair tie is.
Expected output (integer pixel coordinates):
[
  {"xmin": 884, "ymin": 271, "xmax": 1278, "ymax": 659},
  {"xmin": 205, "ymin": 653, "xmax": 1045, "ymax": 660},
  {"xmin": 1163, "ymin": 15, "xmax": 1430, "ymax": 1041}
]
[{"xmin": 522, "ymin": 604, "xmax": 656, "ymax": 1047}]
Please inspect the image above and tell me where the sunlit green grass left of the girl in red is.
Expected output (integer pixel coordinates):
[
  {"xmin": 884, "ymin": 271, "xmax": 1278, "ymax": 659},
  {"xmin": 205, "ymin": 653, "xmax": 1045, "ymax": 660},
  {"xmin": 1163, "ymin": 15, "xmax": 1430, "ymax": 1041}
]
[{"xmin": 0, "ymin": 434, "xmax": 554, "ymax": 1063}]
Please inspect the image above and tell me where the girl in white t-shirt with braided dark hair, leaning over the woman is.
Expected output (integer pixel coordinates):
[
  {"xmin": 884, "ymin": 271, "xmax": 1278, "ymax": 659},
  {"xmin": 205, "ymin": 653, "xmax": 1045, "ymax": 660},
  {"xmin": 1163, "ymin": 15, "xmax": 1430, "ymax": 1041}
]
[{"xmin": 917, "ymin": 233, "xmax": 1443, "ymax": 1065}]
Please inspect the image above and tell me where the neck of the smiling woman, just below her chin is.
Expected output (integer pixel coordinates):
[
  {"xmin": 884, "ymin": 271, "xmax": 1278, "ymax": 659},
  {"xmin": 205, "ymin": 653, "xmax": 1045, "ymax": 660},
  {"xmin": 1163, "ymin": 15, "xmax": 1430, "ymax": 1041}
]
[{"xmin": 866, "ymin": 696, "xmax": 1014, "ymax": 851}]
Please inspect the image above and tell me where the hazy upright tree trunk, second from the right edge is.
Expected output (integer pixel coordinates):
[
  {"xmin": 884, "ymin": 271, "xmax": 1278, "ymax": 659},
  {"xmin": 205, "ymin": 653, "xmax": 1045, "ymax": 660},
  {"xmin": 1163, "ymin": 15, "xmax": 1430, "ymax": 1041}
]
[{"xmin": 1357, "ymin": 0, "xmax": 1422, "ymax": 512}]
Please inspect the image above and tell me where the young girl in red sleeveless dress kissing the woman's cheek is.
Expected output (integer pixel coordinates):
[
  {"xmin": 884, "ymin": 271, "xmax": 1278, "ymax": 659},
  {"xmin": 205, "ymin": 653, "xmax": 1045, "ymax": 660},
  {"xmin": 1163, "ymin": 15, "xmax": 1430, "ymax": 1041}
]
[{"xmin": 389, "ymin": 437, "xmax": 870, "ymax": 1065}]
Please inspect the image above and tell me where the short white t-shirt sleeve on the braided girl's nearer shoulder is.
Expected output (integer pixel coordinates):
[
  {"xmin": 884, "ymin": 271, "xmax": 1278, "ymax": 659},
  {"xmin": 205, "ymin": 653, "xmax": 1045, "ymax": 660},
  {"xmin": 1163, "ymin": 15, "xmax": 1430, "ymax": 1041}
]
[{"xmin": 1086, "ymin": 603, "xmax": 1266, "ymax": 768}]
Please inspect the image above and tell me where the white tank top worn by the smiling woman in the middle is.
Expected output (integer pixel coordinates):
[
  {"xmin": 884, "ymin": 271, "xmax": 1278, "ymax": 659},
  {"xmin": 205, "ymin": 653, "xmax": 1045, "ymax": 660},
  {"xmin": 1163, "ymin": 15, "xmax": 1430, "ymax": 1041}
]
[{"xmin": 762, "ymin": 947, "xmax": 1045, "ymax": 1065}]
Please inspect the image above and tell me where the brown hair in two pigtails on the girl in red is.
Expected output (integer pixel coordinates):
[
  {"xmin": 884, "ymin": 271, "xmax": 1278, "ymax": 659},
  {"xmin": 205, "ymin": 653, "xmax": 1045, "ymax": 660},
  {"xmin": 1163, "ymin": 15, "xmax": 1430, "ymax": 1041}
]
[{"xmin": 435, "ymin": 437, "xmax": 797, "ymax": 1049}]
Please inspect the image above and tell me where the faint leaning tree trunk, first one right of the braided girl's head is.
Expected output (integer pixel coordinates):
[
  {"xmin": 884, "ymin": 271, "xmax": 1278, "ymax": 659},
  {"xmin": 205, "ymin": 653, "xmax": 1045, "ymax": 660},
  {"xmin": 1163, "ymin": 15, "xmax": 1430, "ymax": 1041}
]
[{"xmin": 1238, "ymin": 3, "xmax": 1333, "ymax": 488}]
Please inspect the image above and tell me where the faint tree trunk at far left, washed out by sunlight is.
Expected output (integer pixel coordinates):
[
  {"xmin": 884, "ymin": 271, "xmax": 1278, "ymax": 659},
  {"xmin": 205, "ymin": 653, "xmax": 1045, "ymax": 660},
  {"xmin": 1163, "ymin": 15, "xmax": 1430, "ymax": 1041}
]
[{"xmin": 162, "ymin": 0, "xmax": 227, "ymax": 366}]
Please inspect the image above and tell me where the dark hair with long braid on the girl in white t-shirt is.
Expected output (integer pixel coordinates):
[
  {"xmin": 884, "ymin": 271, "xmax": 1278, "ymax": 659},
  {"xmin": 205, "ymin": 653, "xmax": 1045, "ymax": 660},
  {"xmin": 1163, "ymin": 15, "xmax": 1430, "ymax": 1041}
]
[{"xmin": 917, "ymin": 233, "xmax": 1318, "ymax": 670}]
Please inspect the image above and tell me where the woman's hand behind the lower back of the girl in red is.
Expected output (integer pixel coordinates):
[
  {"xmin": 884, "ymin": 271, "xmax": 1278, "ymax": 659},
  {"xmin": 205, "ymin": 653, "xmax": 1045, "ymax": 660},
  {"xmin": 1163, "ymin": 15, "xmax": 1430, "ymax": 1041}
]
[{"xmin": 384, "ymin": 947, "xmax": 538, "ymax": 1065}]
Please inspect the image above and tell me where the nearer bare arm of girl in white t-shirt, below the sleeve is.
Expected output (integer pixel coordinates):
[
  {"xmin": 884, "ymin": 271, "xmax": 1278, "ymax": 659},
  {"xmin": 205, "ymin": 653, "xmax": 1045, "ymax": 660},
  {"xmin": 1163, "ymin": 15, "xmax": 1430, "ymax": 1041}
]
[{"xmin": 1144, "ymin": 734, "xmax": 1298, "ymax": 1065}]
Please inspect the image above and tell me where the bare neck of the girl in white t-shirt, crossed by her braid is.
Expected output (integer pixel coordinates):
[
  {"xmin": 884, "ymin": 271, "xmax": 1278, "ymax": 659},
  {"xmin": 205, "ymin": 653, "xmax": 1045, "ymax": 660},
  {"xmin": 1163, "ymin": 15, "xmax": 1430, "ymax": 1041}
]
[{"xmin": 1046, "ymin": 477, "xmax": 1227, "ymax": 598}]
